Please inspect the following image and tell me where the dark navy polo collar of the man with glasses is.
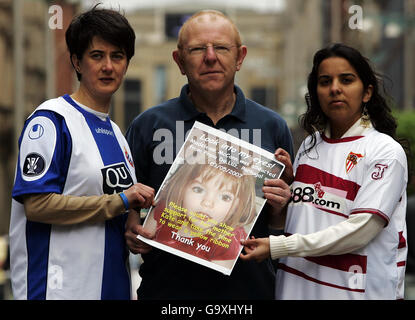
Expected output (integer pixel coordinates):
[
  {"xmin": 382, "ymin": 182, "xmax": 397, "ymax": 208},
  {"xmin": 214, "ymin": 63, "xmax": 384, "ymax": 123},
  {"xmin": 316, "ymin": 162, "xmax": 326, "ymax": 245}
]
[{"xmin": 179, "ymin": 84, "xmax": 246, "ymax": 122}]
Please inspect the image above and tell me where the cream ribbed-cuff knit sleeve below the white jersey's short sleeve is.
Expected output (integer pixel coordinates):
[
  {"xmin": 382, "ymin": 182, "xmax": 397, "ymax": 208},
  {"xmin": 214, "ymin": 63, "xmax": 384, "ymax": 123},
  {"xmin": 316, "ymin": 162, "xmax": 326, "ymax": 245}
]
[{"xmin": 269, "ymin": 213, "xmax": 385, "ymax": 259}]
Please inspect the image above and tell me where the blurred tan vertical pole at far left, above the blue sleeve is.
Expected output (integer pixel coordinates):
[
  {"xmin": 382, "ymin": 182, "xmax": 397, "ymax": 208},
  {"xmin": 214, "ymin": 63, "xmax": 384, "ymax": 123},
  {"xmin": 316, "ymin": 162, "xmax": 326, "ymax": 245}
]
[{"xmin": 13, "ymin": 0, "xmax": 25, "ymax": 156}]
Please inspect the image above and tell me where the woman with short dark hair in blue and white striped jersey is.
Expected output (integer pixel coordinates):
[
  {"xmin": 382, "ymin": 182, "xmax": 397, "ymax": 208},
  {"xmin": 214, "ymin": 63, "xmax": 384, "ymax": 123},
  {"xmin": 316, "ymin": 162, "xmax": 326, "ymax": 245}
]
[{"xmin": 10, "ymin": 7, "xmax": 154, "ymax": 300}]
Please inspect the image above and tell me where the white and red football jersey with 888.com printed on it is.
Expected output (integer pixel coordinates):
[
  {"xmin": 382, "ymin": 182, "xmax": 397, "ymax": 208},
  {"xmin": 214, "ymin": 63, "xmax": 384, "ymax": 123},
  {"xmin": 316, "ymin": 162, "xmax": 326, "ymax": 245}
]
[{"xmin": 276, "ymin": 128, "xmax": 408, "ymax": 299}]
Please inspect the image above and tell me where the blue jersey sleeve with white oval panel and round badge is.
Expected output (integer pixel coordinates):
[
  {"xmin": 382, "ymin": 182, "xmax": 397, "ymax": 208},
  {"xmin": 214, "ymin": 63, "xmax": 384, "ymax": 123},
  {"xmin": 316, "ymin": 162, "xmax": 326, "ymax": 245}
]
[{"xmin": 12, "ymin": 110, "xmax": 72, "ymax": 202}]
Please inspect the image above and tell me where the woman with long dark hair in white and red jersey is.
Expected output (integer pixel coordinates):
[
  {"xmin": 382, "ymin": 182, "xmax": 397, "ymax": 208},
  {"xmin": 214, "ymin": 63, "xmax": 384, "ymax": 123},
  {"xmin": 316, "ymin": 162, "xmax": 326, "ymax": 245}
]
[{"xmin": 241, "ymin": 44, "xmax": 408, "ymax": 299}]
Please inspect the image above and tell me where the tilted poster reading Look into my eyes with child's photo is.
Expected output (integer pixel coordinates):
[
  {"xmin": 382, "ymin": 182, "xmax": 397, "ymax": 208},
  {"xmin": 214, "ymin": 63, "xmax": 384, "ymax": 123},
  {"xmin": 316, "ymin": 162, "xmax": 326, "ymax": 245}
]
[{"xmin": 138, "ymin": 122, "xmax": 284, "ymax": 275}]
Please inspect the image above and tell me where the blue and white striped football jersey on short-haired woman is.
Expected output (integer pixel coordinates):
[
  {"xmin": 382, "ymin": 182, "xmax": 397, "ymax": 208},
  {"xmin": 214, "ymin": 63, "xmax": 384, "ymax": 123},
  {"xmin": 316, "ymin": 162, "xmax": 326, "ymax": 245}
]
[{"xmin": 10, "ymin": 95, "xmax": 136, "ymax": 299}]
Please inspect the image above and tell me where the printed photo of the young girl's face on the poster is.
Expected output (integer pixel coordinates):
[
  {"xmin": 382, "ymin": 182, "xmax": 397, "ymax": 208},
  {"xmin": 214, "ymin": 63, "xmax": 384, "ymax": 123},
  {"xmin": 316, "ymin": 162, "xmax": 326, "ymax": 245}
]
[{"xmin": 144, "ymin": 162, "xmax": 256, "ymax": 266}]
